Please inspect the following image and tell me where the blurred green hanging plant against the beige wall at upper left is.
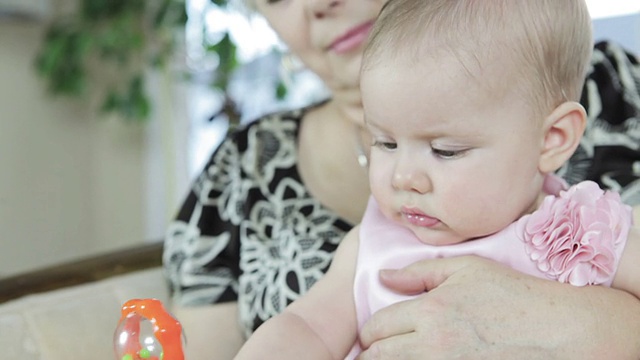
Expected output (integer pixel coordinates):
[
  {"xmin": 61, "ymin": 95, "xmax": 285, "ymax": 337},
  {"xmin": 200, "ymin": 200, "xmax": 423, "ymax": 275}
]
[{"xmin": 35, "ymin": 0, "xmax": 187, "ymax": 121}]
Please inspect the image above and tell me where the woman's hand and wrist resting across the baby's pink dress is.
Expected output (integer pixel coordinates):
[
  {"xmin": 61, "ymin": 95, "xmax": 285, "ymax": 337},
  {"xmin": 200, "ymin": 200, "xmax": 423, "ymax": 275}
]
[{"xmin": 359, "ymin": 256, "xmax": 640, "ymax": 360}]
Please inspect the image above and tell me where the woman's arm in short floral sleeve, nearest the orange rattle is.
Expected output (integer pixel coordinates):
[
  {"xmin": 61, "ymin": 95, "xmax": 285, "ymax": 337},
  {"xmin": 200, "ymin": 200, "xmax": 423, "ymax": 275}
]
[{"xmin": 163, "ymin": 131, "xmax": 244, "ymax": 360}]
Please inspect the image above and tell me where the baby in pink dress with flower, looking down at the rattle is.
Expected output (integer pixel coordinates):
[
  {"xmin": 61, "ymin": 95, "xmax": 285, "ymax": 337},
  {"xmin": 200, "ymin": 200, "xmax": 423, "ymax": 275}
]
[{"xmin": 237, "ymin": 0, "xmax": 640, "ymax": 359}]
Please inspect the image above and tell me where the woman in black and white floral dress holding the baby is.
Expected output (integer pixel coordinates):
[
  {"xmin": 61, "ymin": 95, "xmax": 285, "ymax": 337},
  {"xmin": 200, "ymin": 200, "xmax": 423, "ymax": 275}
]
[{"xmin": 164, "ymin": 0, "xmax": 640, "ymax": 359}]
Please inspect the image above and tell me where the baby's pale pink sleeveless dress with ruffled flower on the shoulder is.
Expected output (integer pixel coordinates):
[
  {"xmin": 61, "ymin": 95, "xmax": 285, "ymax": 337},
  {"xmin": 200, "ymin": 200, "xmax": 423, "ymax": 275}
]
[{"xmin": 347, "ymin": 175, "xmax": 632, "ymax": 359}]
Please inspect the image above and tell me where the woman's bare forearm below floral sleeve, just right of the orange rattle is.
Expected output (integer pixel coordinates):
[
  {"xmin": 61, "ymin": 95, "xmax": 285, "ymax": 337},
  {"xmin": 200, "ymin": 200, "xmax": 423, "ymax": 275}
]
[{"xmin": 173, "ymin": 302, "xmax": 244, "ymax": 360}]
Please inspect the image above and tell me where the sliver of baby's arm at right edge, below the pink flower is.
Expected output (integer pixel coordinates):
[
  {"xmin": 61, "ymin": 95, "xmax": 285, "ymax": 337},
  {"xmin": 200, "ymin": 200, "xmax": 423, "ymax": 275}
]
[{"xmin": 611, "ymin": 227, "xmax": 640, "ymax": 299}]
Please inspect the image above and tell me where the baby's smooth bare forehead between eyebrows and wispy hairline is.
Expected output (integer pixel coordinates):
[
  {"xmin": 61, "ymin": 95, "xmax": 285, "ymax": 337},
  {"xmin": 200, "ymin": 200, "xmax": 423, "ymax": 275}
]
[{"xmin": 361, "ymin": 50, "xmax": 539, "ymax": 118}]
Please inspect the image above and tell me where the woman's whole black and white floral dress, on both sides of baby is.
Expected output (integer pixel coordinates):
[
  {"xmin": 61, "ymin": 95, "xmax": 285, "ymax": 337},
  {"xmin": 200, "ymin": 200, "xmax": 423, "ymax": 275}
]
[{"xmin": 163, "ymin": 42, "xmax": 640, "ymax": 335}]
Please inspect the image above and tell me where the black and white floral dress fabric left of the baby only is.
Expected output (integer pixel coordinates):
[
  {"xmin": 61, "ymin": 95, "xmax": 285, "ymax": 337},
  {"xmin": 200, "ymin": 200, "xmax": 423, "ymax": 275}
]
[{"xmin": 163, "ymin": 105, "xmax": 352, "ymax": 334}]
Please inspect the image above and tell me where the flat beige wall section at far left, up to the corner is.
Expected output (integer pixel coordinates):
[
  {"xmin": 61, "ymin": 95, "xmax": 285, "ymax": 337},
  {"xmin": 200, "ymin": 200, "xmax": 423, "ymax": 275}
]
[{"xmin": 0, "ymin": 20, "xmax": 93, "ymax": 275}]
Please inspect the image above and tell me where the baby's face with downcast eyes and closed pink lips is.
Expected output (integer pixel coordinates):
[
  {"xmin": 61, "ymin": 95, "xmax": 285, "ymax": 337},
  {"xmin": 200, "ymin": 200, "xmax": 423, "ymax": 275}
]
[{"xmin": 361, "ymin": 52, "xmax": 544, "ymax": 245}]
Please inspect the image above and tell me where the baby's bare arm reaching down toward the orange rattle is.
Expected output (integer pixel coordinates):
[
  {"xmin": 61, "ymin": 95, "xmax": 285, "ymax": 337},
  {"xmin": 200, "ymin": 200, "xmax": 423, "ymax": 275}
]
[{"xmin": 236, "ymin": 227, "xmax": 359, "ymax": 360}]
